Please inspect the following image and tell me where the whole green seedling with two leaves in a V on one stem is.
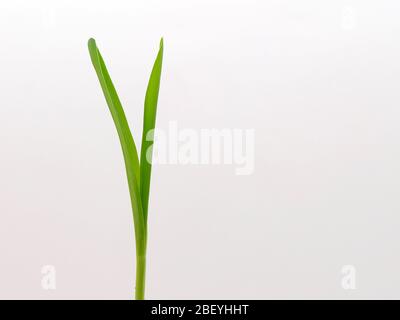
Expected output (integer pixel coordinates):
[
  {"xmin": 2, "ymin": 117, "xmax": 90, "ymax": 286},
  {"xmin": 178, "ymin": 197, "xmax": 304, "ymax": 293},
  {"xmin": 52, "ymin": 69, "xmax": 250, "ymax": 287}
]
[{"xmin": 88, "ymin": 39, "xmax": 163, "ymax": 300}]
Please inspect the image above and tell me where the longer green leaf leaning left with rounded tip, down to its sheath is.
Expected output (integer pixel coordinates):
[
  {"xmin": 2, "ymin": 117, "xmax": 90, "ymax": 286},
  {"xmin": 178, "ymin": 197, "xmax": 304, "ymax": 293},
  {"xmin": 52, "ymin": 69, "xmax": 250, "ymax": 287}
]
[{"xmin": 88, "ymin": 39, "xmax": 146, "ymax": 255}]
